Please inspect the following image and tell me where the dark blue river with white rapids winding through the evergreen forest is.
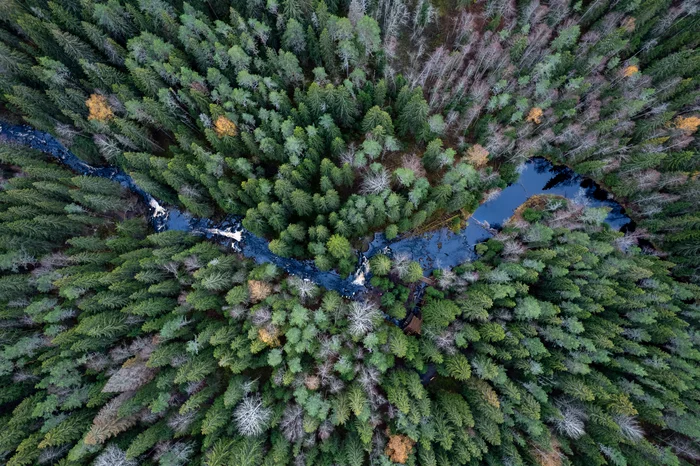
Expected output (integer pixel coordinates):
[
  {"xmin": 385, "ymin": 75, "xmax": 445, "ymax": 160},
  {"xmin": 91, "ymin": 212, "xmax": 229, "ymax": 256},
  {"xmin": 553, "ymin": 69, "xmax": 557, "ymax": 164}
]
[{"xmin": 0, "ymin": 123, "xmax": 630, "ymax": 296}]
